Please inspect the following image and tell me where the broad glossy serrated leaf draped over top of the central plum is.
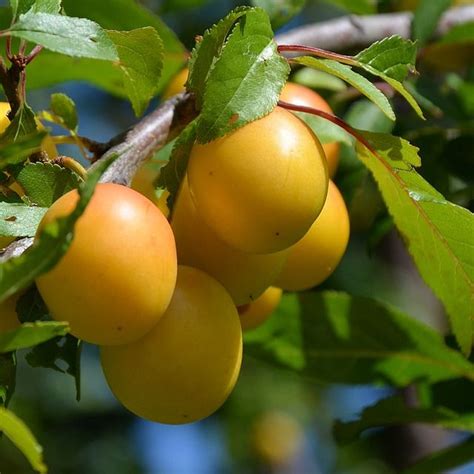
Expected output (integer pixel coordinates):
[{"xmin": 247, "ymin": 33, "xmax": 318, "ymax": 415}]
[{"xmin": 197, "ymin": 9, "xmax": 290, "ymax": 143}]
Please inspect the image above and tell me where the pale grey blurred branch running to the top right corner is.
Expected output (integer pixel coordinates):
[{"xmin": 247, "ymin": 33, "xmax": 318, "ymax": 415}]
[{"xmin": 275, "ymin": 5, "xmax": 474, "ymax": 51}]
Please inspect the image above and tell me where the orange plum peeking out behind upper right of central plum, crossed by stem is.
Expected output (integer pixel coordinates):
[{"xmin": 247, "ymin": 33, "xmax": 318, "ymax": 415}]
[{"xmin": 280, "ymin": 82, "xmax": 340, "ymax": 178}]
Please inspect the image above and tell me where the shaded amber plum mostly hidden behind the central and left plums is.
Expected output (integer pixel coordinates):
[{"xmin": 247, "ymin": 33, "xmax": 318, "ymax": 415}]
[{"xmin": 171, "ymin": 178, "xmax": 287, "ymax": 305}]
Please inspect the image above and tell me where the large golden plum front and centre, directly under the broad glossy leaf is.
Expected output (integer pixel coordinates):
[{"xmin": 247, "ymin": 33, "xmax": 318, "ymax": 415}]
[{"xmin": 188, "ymin": 107, "xmax": 328, "ymax": 253}]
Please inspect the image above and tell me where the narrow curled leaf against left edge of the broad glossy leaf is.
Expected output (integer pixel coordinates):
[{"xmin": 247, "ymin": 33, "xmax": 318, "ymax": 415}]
[{"xmin": 187, "ymin": 7, "xmax": 254, "ymax": 110}]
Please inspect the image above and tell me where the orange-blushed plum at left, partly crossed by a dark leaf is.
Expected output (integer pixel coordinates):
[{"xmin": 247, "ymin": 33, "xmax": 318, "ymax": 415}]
[{"xmin": 36, "ymin": 183, "xmax": 177, "ymax": 345}]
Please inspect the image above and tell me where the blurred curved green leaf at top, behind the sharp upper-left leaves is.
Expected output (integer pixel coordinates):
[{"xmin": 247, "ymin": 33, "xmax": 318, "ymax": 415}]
[{"xmin": 62, "ymin": 0, "xmax": 187, "ymax": 92}]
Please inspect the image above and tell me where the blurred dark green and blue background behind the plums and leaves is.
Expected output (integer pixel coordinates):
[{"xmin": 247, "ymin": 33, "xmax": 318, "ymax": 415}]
[{"xmin": 0, "ymin": 0, "xmax": 474, "ymax": 474}]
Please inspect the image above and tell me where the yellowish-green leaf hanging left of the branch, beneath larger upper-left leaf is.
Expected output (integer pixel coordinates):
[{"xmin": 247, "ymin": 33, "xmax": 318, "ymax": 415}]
[{"xmin": 107, "ymin": 27, "xmax": 163, "ymax": 116}]
